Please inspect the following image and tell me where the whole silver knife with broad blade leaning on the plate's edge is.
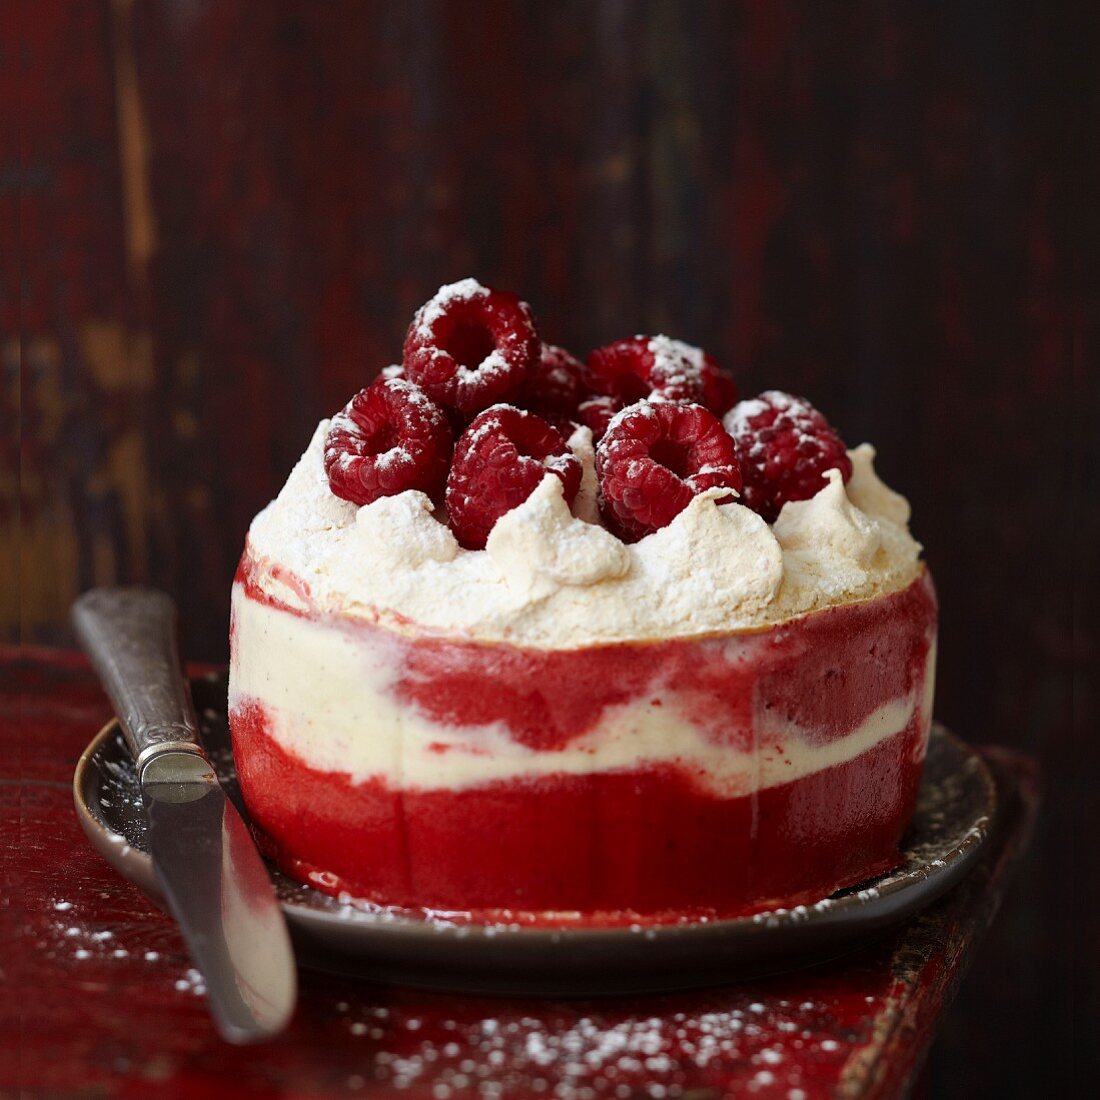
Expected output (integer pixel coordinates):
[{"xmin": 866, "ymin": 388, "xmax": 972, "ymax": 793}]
[{"xmin": 73, "ymin": 589, "xmax": 297, "ymax": 1043}]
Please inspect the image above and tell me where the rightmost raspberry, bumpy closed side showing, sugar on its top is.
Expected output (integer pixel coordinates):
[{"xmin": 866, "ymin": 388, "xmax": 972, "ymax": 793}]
[{"xmin": 724, "ymin": 389, "xmax": 851, "ymax": 524}]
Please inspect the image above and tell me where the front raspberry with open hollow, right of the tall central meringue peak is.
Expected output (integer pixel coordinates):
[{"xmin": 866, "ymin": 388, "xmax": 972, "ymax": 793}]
[{"xmin": 596, "ymin": 402, "xmax": 741, "ymax": 542}]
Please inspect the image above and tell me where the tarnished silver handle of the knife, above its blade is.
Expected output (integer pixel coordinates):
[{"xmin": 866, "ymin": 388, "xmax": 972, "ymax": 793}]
[{"xmin": 73, "ymin": 589, "xmax": 202, "ymax": 776}]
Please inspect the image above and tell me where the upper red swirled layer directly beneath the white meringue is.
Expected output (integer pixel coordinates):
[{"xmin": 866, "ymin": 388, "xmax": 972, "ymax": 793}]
[{"xmin": 237, "ymin": 550, "xmax": 936, "ymax": 750}]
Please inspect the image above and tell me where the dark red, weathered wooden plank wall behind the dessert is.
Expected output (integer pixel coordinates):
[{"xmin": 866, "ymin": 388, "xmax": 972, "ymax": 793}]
[{"xmin": 0, "ymin": 0, "xmax": 1100, "ymax": 1096}]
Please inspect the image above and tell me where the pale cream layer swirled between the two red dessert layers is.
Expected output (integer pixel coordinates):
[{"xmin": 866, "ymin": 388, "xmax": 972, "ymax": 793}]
[{"xmin": 230, "ymin": 584, "xmax": 935, "ymax": 798}]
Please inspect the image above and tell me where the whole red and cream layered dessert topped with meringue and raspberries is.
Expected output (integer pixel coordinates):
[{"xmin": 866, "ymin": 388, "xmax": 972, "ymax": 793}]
[{"xmin": 230, "ymin": 279, "xmax": 936, "ymax": 920}]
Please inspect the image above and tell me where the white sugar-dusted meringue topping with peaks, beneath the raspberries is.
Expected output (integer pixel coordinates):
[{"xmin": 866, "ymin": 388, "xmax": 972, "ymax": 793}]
[{"xmin": 249, "ymin": 421, "xmax": 921, "ymax": 648}]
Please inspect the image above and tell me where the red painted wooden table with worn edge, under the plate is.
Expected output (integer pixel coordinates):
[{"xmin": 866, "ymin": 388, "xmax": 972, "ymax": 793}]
[{"xmin": 0, "ymin": 651, "xmax": 1036, "ymax": 1100}]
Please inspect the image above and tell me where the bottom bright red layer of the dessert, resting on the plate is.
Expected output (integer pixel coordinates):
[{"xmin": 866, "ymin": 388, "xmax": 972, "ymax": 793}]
[{"xmin": 233, "ymin": 704, "xmax": 921, "ymax": 920}]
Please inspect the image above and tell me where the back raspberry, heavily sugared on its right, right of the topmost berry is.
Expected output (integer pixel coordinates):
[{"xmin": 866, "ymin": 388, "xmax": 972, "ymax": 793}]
[{"xmin": 586, "ymin": 337, "xmax": 717, "ymax": 405}]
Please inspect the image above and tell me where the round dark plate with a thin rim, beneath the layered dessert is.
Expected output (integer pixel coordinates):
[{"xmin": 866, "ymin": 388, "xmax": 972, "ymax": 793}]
[{"xmin": 73, "ymin": 677, "xmax": 998, "ymax": 996}]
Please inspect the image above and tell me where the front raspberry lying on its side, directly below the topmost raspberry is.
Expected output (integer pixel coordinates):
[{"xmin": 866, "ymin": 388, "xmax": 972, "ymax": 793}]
[{"xmin": 447, "ymin": 405, "xmax": 581, "ymax": 550}]
